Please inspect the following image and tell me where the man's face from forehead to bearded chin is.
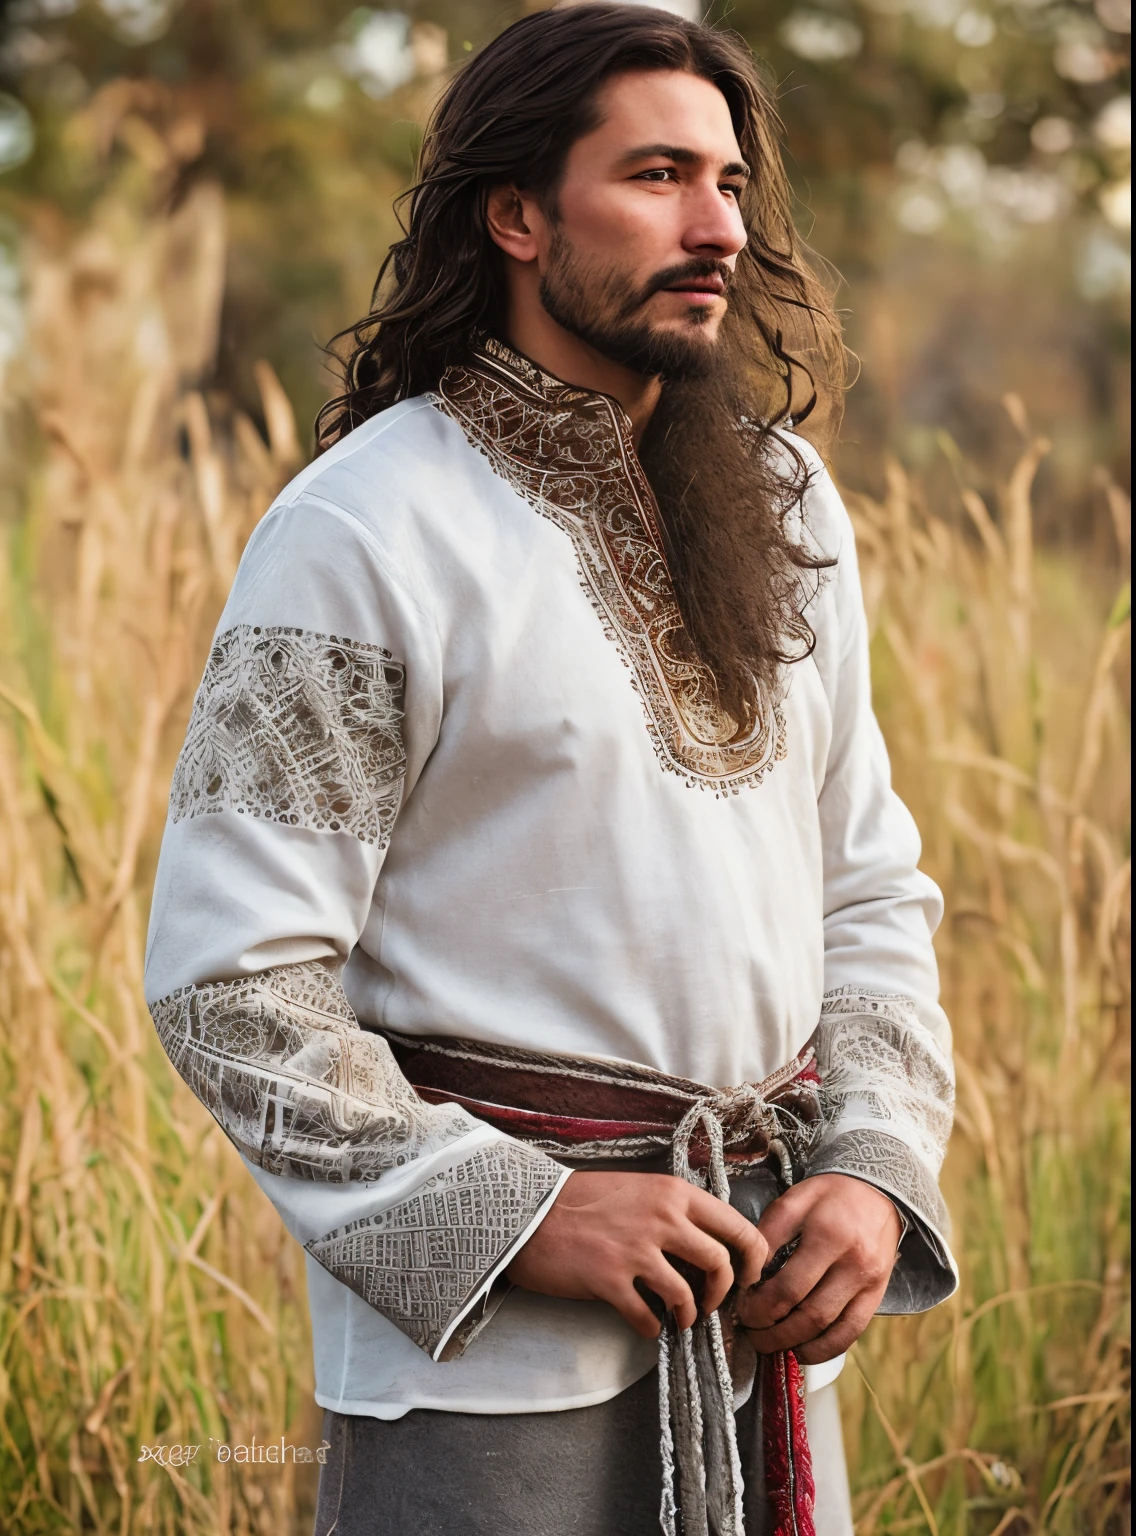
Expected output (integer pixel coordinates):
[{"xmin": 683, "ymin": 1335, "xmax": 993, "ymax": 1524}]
[{"xmin": 537, "ymin": 71, "xmax": 749, "ymax": 378}]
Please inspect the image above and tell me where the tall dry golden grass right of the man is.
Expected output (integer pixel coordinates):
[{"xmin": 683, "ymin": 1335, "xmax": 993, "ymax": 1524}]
[{"xmin": 843, "ymin": 436, "xmax": 1131, "ymax": 1536}]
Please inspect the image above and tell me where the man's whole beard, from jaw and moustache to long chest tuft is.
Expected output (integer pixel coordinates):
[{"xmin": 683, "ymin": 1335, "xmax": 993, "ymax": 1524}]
[{"xmin": 540, "ymin": 230, "xmax": 832, "ymax": 739}]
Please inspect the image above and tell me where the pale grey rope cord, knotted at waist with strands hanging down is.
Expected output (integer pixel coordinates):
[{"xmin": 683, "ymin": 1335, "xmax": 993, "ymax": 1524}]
[{"xmin": 659, "ymin": 1083, "xmax": 792, "ymax": 1536}]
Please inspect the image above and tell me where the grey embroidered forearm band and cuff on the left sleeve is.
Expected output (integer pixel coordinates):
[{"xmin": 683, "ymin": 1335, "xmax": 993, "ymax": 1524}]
[{"xmin": 150, "ymin": 962, "xmax": 565, "ymax": 1355}]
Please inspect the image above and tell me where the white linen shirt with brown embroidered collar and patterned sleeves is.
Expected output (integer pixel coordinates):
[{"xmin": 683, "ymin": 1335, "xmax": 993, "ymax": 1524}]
[{"xmin": 146, "ymin": 343, "xmax": 955, "ymax": 1418}]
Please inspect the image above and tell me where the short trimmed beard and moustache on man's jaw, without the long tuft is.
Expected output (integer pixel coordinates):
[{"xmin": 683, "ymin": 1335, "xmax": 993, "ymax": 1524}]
[{"xmin": 540, "ymin": 229, "xmax": 732, "ymax": 379}]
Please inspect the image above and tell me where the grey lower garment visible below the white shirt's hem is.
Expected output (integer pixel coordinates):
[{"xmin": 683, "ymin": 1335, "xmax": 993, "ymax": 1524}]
[{"xmin": 316, "ymin": 1372, "xmax": 852, "ymax": 1536}]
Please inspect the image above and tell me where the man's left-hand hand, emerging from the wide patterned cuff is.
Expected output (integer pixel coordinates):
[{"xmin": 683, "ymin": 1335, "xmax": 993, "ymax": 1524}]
[{"xmin": 508, "ymin": 1174, "xmax": 771, "ymax": 1339}]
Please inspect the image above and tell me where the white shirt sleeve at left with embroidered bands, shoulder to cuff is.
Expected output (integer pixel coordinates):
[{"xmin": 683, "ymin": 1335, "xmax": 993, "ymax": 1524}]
[{"xmin": 146, "ymin": 496, "xmax": 568, "ymax": 1359}]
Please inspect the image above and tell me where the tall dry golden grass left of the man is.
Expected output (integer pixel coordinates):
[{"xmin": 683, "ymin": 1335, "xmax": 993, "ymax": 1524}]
[{"xmin": 0, "ymin": 174, "xmax": 318, "ymax": 1536}]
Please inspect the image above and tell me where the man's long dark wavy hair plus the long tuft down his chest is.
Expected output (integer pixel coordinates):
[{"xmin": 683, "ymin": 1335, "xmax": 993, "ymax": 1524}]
[{"xmin": 316, "ymin": 0, "xmax": 844, "ymax": 733}]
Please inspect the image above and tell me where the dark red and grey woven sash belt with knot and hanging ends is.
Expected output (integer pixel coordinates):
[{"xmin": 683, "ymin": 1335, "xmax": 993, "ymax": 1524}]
[{"xmin": 384, "ymin": 1031, "xmax": 820, "ymax": 1536}]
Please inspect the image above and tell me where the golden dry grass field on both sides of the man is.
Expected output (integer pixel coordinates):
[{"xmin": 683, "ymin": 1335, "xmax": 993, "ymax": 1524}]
[{"xmin": 0, "ymin": 162, "xmax": 1130, "ymax": 1536}]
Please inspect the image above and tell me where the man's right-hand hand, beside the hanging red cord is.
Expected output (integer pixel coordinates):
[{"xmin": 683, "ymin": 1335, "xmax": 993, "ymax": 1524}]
[{"xmin": 737, "ymin": 1174, "xmax": 903, "ymax": 1366}]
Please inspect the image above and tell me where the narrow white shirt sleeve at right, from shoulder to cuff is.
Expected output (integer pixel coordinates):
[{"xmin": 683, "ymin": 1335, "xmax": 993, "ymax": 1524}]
[{"xmin": 807, "ymin": 454, "xmax": 958, "ymax": 1312}]
